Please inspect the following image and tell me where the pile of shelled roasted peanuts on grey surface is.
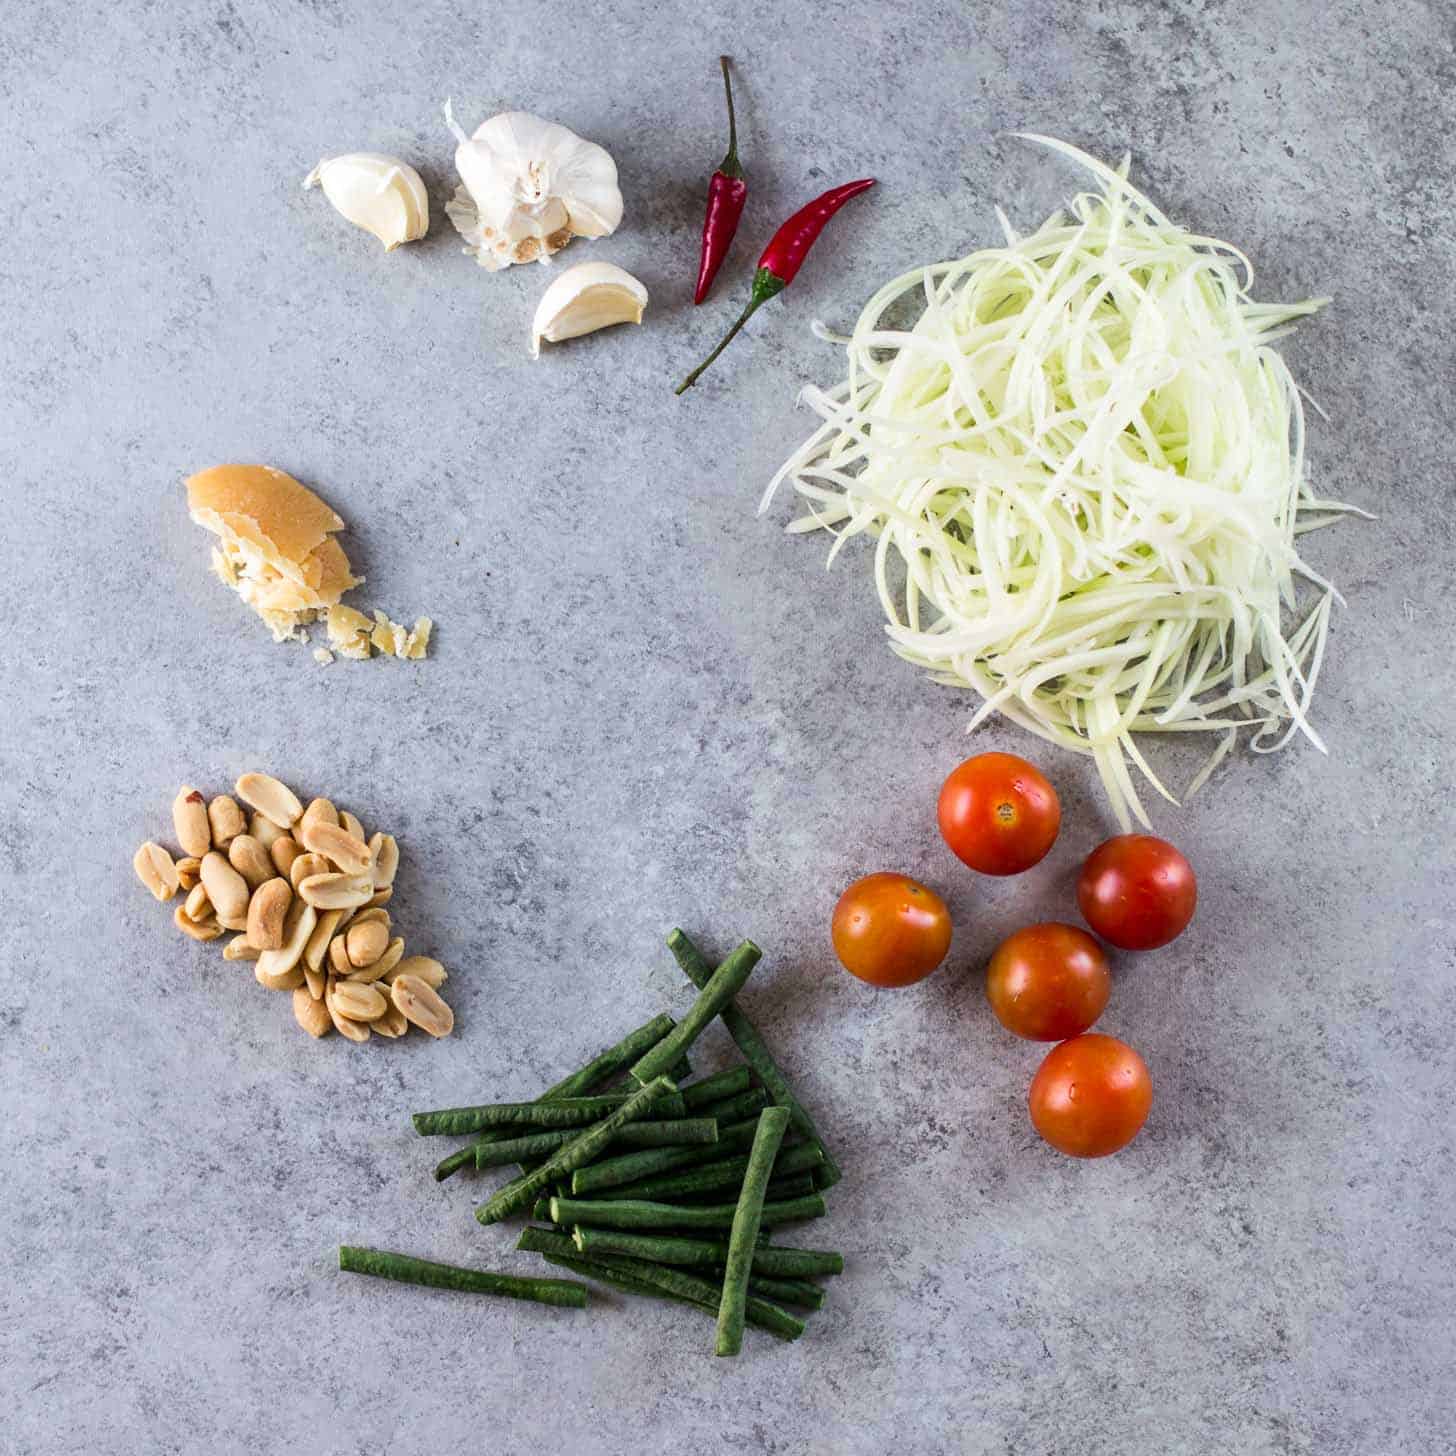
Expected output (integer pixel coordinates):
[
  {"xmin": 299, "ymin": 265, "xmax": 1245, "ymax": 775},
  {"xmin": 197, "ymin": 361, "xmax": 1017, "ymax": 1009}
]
[{"xmin": 132, "ymin": 773, "xmax": 454, "ymax": 1041}]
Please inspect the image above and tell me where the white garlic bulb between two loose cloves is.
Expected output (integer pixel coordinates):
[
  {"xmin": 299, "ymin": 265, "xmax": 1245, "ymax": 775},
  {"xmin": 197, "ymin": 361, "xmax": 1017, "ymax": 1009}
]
[{"xmin": 446, "ymin": 102, "xmax": 622, "ymax": 272}]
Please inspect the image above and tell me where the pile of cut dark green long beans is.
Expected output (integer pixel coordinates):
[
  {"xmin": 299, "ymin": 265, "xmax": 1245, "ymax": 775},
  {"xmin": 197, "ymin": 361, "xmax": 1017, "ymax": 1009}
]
[{"xmin": 339, "ymin": 930, "xmax": 844, "ymax": 1356}]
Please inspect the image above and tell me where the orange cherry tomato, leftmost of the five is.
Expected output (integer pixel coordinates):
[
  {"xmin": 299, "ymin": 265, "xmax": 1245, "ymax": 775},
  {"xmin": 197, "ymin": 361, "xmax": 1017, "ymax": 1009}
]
[{"xmin": 833, "ymin": 874, "xmax": 951, "ymax": 986}]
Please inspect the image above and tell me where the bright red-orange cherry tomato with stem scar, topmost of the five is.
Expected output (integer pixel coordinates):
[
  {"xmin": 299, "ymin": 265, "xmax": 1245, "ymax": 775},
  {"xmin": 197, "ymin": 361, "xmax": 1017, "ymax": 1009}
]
[{"xmin": 936, "ymin": 753, "xmax": 1061, "ymax": 875}]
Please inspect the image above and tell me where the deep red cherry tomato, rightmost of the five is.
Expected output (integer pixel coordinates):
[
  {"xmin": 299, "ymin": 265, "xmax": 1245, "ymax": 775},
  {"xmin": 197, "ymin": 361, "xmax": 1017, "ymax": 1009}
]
[{"xmin": 1077, "ymin": 834, "xmax": 1198, "ymax": 951}]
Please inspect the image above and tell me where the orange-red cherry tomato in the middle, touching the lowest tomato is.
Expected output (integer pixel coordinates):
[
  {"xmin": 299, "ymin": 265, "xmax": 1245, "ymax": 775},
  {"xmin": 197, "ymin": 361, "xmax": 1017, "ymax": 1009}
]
[{"xmin": 986, "ymin": 922, "xmax": 1112, "ymax": 1041}]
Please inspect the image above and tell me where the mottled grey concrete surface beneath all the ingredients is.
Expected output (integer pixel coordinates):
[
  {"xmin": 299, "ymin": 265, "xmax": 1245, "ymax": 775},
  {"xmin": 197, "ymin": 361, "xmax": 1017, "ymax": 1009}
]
[{"xmin": 0, "ymin": 0, "xmax": 1456, "ymax": 1456}]
